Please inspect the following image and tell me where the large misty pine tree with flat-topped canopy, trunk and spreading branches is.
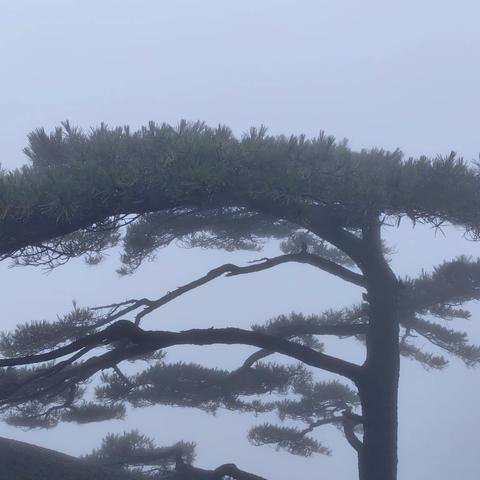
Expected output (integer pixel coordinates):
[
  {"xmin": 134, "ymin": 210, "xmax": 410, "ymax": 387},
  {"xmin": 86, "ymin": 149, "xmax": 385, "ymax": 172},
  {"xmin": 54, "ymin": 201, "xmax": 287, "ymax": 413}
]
[{"xmin": 0, "ymin": 122, "xmax": 480, "ymax": 480}]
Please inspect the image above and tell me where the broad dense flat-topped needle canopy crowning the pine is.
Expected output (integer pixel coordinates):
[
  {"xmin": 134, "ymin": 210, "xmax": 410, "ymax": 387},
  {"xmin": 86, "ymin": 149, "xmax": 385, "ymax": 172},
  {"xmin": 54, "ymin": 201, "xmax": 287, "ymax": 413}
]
[{"xmin": 0, "ymin": 122, "xmax": 480, "ymax": 273}]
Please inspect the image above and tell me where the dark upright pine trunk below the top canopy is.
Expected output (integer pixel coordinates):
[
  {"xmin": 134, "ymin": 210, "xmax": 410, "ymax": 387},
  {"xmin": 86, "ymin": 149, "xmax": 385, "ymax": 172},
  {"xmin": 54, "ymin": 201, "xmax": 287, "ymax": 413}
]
[{"xmin": 358, "ymin": 251, "xmax": 400, "ymax": 480}]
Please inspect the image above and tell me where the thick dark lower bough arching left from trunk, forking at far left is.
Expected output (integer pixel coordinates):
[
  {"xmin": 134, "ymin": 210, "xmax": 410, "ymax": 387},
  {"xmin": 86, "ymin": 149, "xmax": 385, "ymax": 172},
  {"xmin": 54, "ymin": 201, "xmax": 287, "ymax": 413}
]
[{"xmin": 0, "ymin": 320, "xmax": 362, "ymax": 404}]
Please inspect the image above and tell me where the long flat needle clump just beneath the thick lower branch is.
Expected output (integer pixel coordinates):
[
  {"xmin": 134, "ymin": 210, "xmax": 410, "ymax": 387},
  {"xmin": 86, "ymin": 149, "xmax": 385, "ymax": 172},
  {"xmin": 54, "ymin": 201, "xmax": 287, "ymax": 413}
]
[{"xmin": 96, "ymin": 362, "xmax": 308, "ymax": 413}]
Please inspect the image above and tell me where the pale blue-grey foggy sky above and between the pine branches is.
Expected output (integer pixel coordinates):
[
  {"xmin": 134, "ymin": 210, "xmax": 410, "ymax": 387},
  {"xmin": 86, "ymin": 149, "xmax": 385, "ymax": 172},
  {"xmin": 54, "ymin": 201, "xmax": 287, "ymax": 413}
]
[{"xmin": 0, "ymin": 0, "xmax": 480, "ymax": 480}]
